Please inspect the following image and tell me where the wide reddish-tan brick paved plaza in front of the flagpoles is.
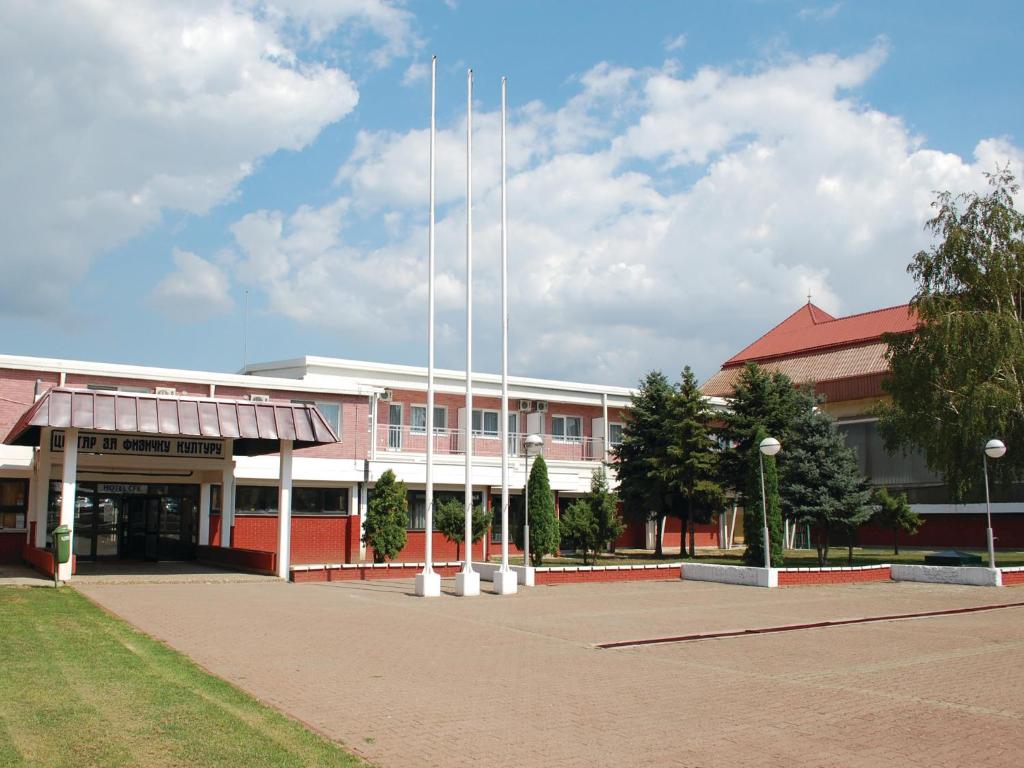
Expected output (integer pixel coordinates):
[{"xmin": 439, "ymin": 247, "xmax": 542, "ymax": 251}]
[{"xmin": 79, "ymin": 582, "xmax": 1024, "ymax": 768}]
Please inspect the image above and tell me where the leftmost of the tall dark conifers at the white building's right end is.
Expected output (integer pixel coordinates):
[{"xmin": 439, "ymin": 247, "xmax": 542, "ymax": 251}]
[{"xmin": 611, "ymin": 371, "xmax": 672, "ymax": 557}]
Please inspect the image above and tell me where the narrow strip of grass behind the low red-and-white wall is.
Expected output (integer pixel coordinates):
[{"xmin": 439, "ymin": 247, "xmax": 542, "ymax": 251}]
[{"xmin": 490, "ymin": 547, "xmax": 1024, "ymax": 568}]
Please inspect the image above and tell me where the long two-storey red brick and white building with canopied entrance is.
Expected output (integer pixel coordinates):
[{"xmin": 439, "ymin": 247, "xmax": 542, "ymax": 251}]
[{"xmin": 0, "ymin": 355, "xmax": 675, "ymax": 572}]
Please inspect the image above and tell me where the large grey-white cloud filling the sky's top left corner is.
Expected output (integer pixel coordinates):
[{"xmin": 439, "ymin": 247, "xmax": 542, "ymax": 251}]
[{"xmin": 0, "ymin": 0, "xmax": 414, "ymax": 316}]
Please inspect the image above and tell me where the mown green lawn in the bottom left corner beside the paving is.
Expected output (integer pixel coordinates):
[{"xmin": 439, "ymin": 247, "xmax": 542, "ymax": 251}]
[{"xmin": 0, "ymin": 587, "xmax": 367, "ymax": 768}]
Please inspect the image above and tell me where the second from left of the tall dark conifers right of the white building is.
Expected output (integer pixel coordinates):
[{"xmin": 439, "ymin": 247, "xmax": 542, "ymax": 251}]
[{"xmin": 662, "ymin": 366, "xmax": 725, "ymax": 557}]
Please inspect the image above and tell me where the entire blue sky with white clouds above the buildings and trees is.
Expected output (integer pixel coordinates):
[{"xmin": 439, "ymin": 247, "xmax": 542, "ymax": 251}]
[{"xmin": 0, "ymin": 0, "xmax": 1024, "ymax": 385}]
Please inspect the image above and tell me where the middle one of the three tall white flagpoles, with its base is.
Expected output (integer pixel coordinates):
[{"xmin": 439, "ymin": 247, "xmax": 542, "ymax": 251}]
[{"xmin": 455, "ymin": 70, "xmax": 480, "ymax": 597}]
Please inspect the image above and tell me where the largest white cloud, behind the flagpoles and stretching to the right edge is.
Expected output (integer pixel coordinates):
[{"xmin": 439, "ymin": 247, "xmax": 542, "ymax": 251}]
[{"xmin": 186, "ymin": 45, "xmax": 1024, "ymax": 383}]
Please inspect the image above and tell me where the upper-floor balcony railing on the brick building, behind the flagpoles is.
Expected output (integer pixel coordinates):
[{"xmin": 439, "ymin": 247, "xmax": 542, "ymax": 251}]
[{"xmin": 376, "ymin": 424, "xmax": 604, "ymax": 462}]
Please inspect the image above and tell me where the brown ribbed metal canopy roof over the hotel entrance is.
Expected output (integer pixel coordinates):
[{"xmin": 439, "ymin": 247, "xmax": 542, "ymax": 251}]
[{"xmin": 4, "ymin": 387, "xmax": 338, "ymax": 456}]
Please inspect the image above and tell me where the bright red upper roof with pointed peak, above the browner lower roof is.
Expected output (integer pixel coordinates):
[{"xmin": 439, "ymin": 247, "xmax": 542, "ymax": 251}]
[{"xmin": 722, "ymin": 302, "xmax": 916, "ymax": 369}]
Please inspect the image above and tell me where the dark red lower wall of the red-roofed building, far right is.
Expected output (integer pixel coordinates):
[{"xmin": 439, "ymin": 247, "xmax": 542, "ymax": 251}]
[{"xmin": 857, "ymin": 514, "xmax": 1024, "ymax": 549}]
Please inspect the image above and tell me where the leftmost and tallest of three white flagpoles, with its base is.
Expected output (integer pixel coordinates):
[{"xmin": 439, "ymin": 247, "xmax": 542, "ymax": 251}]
[{"xmin": 416, "ymin": 56, "xmax": 441, "ymax": 597}]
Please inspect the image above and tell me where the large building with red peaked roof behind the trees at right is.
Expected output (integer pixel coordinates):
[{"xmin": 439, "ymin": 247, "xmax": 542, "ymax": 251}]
[{"xmin": 701, "ymin": 301, "xmax": 1024, "ymax": 548}]
